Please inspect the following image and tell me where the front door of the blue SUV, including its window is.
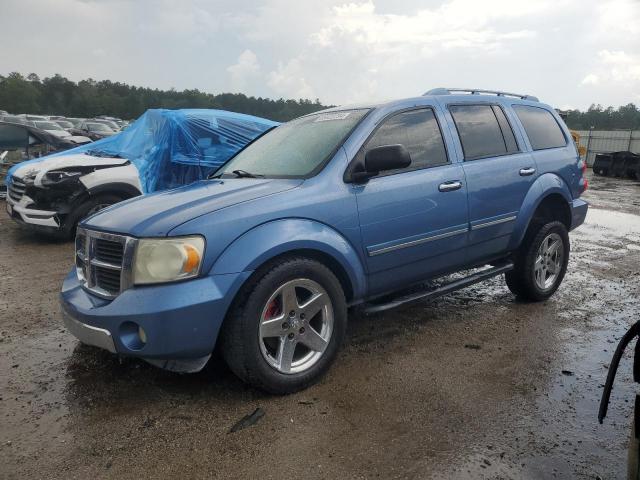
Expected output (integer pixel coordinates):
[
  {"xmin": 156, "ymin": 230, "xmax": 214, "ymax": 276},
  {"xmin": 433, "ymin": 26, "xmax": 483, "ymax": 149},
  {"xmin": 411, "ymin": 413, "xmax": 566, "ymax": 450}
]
[{"xmin": 353, "ymin": 106, "xmax": 468, "ymax": 294}]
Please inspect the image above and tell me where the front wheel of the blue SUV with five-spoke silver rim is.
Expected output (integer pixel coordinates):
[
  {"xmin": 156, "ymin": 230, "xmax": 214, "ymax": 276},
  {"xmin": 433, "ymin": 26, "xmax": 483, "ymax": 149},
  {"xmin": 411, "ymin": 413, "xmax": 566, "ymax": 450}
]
[{"xmin": 221, "ymin": 257, "xmax": 347, "ymax": 395}]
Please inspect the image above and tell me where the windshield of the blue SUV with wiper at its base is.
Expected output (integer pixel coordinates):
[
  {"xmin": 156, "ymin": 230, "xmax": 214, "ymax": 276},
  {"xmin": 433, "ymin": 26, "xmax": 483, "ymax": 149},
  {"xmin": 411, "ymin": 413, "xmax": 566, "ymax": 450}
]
[{"xmin": 215, "ymin": 110, "xmax": 368, "ymax": 178}]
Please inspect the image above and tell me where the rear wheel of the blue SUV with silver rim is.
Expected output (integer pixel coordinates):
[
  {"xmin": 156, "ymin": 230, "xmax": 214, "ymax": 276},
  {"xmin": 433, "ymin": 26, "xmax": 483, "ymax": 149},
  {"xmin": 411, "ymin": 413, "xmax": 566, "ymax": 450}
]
[{"xmin": 505, "ymin": 221, "xmax": 570, "ymax": 302}]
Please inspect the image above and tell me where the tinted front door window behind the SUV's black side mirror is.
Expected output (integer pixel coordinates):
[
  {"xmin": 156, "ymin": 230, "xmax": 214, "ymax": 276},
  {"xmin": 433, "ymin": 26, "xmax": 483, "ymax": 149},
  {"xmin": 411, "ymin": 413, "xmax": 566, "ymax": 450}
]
[{"xmin": 366, "ymin": 108, "xmax": 447, "ymax": 175}]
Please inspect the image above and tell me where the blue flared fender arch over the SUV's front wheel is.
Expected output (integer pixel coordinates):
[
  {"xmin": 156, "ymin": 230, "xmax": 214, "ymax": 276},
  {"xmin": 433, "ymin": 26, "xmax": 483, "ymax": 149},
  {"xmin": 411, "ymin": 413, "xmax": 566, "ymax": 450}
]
[{"xmin": 210, "ymin": 218, "xmax": 366, "ymax": 301}]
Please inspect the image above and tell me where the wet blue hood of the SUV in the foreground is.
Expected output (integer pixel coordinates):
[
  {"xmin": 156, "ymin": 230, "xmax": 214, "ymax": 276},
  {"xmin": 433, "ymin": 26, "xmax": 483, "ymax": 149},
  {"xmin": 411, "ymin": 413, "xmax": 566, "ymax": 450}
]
[{"xmin": 82, "ymin": 178, "xmax": 303, "ymax": 237}]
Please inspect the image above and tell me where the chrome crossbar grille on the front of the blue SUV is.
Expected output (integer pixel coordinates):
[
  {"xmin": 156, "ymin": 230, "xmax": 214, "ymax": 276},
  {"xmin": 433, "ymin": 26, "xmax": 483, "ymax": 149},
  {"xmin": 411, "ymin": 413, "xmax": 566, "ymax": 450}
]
[{"xmin": 75, "ymin": 228, "xmax": 137, "ymax": 299}]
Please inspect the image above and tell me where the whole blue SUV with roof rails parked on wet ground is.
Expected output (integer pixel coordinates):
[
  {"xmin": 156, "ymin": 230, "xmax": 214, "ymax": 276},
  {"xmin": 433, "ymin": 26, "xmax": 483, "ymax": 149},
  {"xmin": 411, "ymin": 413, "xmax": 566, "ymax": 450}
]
[{"xmin": 61, "ymin": 88, "xmax": 587, "ymax": 394}]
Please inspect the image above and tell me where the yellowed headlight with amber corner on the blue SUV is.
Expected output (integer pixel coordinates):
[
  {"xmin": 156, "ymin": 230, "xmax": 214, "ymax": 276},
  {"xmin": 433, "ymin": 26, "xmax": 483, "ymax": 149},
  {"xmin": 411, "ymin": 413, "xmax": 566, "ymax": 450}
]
[{"xmin": 133, "ymin": 236, "xmax": 204, "ymax": 285}]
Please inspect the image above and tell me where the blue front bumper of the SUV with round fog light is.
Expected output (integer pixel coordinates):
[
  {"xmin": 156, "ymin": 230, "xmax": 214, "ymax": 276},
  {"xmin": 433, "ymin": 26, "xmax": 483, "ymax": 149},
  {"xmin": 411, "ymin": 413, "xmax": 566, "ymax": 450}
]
[{"xmin": 60, "ymin": 269, "xmax": 251, "ymax": 371}]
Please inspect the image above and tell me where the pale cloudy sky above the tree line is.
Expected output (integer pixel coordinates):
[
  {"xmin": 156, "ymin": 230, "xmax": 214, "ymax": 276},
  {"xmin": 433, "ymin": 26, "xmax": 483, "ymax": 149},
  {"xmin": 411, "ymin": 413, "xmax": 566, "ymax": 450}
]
[{"xmin": 0, "ymin": 0, "xmax": 640, "ymax": 109}]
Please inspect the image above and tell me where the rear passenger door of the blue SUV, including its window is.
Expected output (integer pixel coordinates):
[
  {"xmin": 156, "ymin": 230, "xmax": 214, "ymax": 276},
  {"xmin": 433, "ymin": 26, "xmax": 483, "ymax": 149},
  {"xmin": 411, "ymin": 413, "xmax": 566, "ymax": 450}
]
[{"xmin": 448, "ymin": 103, "xmax": 537, "ymax": 263}]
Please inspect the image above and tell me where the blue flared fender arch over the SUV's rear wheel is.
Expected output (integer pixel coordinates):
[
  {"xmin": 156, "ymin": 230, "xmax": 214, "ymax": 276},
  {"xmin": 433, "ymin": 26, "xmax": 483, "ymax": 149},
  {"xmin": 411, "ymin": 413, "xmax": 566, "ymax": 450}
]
[{"xmin": 509, "ymin": 173, "xmax": 573, "ymax": 250}]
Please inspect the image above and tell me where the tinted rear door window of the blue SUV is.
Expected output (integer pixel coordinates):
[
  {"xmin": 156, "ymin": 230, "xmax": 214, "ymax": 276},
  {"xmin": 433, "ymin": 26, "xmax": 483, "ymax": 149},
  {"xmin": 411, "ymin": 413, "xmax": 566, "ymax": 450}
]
[{"xmin": 449, "ymin": 105, "xmax": 518, "ymax": 160}]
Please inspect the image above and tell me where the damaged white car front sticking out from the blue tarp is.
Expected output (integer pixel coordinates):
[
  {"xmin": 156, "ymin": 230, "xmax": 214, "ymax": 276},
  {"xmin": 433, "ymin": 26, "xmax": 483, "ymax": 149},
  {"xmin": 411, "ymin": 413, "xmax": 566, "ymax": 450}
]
[{"xmin": 7, "ymin": 151, "xmax": 142, "ymax": 238}]
